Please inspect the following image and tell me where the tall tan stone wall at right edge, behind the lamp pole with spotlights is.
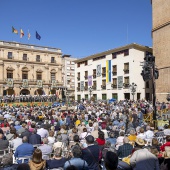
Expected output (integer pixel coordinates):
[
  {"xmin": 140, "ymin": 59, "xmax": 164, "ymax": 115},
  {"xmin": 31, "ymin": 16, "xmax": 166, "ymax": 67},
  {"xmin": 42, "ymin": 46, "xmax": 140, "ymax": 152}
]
[{"xmin": 151, "ymin": 0, "xmax": 170, "ymax": 101}]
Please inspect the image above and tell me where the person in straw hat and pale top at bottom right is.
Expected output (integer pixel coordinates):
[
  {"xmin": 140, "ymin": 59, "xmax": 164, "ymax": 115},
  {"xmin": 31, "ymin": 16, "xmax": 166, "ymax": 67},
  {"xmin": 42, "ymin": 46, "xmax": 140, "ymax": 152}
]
[{"xmin": 130, "ymin": 138, "xmax": 159, "ymax": 170}]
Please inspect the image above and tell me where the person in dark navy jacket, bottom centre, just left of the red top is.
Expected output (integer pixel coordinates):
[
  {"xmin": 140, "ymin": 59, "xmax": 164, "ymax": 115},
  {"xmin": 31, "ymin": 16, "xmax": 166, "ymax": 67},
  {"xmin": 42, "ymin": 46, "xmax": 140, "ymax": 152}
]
[{"xmin": 82, "ymin": 135, "xmax": 101, "ymax": 170}]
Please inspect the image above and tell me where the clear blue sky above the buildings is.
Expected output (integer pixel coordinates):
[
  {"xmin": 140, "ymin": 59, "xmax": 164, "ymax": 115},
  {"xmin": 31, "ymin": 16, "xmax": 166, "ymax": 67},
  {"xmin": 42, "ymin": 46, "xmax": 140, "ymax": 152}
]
[{"xmin": 0, "ymin": 0, "xmax": 152, "ymax": 58}]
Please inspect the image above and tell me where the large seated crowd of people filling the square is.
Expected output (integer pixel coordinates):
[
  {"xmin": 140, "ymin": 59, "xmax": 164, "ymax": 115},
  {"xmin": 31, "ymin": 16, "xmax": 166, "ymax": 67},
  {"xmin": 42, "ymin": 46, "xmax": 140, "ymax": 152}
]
[{"xmin": 0, "ymin": 100, "xmax": 170, "ymax": 170}]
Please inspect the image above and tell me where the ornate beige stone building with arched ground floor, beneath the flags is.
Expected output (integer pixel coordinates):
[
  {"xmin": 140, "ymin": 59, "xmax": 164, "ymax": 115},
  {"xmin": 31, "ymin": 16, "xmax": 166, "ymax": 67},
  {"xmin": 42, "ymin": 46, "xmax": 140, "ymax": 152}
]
[{"xmin": 0, "ymin": 41, "xmax": 63, "ymax": 97}]
